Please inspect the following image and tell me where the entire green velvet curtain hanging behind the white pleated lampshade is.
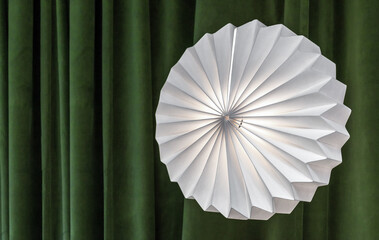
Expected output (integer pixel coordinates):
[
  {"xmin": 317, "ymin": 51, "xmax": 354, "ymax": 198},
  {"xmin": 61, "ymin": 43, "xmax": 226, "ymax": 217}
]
[{"xmin": 0, "ymin": 0, "xmax": 379, "ymax": 240}]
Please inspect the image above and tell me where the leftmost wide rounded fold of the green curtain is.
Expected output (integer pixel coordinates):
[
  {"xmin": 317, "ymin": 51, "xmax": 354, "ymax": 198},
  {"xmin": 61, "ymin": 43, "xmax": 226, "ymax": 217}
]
[{"xmin": 8, "ymin": 0, "xmax": 42, "ymax": 239}]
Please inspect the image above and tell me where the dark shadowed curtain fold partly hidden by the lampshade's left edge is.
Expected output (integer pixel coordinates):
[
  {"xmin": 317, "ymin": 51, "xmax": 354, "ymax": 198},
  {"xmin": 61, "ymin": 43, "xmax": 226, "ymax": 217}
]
[{"xmin": 150, "ymin": 0, "xmax": 195, "ymax": 239}]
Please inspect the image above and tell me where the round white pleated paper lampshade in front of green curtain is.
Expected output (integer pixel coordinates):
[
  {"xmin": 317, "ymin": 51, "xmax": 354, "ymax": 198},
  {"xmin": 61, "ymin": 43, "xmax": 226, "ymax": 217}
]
[{"xmin": 156, "ymin": 20, "xmax": 351, "ymax": 219}]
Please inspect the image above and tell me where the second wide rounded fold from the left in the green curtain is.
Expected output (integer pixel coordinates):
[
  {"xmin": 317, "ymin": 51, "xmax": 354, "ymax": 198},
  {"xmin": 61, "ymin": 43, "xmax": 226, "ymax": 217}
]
[{"xmin": 69, "ymin": 0, "xmax": 103, "ymax": 239}]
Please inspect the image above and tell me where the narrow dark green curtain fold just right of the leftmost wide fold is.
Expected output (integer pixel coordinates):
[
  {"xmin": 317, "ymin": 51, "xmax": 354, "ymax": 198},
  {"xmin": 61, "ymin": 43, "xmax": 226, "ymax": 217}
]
[{"xmin": 40, "ymin": 0, "xmax": 63, "ymax": 239}]
